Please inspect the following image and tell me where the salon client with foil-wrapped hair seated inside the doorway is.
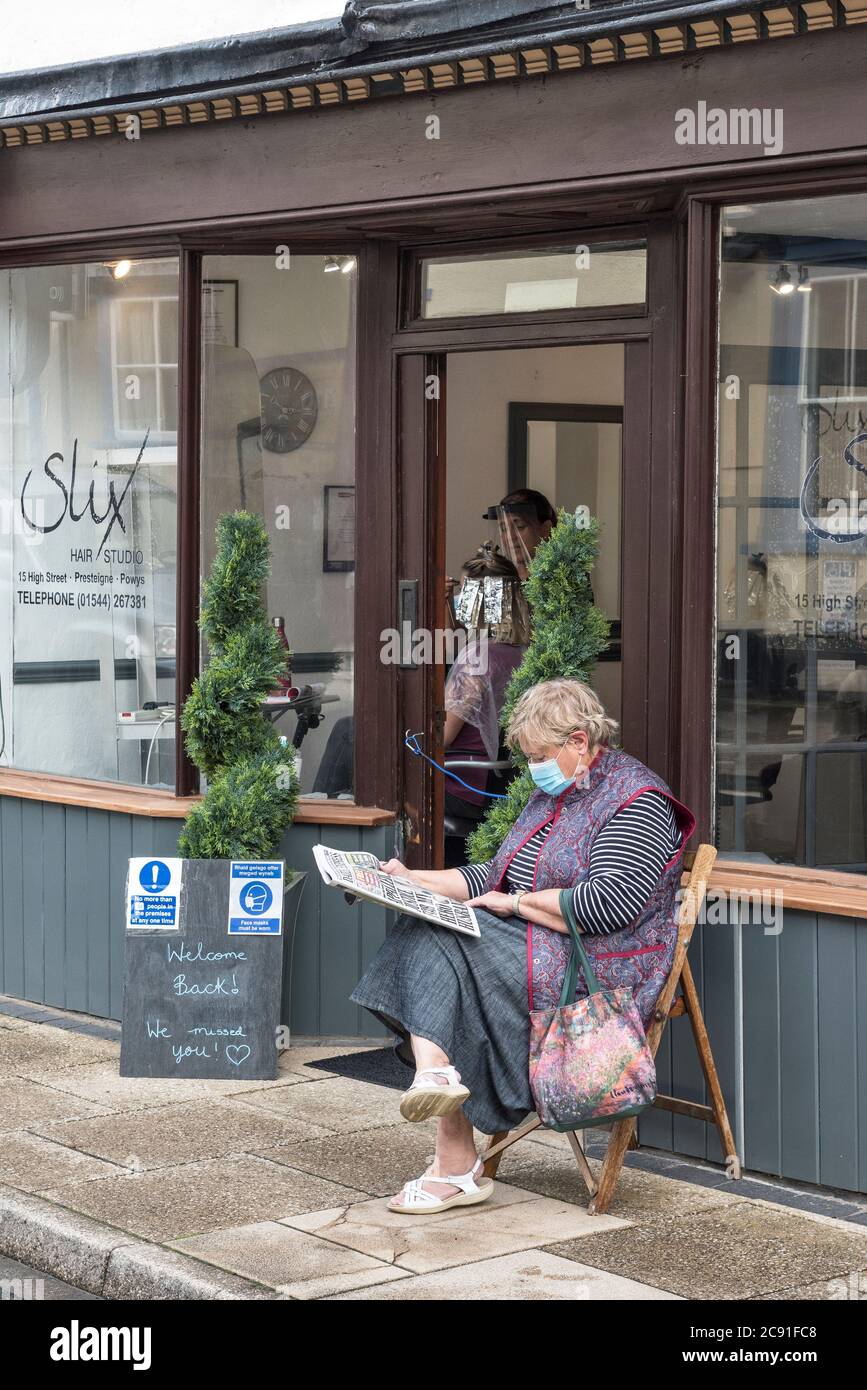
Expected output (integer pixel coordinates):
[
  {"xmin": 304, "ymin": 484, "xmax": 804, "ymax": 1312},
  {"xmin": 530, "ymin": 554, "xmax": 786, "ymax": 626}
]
[{"xmin": 443, "ymin": 545, "xmax": 529, "ymax": 820}]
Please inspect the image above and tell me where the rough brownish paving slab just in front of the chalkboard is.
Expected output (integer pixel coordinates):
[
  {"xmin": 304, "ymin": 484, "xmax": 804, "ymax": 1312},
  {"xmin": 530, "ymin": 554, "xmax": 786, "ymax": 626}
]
[{"xmin": 31, "ymin": 1098, "xmax": 334, "ymax": 1170}]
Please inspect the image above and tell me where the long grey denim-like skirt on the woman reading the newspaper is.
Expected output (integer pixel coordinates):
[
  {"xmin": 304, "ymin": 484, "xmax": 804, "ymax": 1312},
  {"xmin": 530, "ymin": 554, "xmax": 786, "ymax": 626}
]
[{"xmin": 350, "ymin": 908, "xmax": 535, "ymax": 1134}]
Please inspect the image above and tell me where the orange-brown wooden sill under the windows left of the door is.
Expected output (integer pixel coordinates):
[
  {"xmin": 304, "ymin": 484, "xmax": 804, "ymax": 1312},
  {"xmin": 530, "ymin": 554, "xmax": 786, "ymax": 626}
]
[{"xmin": 0, "ymin": 767, "xmax": 395, "ymax": 826}]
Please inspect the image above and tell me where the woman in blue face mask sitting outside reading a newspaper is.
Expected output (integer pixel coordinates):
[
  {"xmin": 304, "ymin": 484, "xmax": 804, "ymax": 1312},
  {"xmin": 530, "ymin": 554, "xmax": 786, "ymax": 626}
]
[{"xmin": 350, "ymin": 680, "xmax": 695, "ymax": 1213}]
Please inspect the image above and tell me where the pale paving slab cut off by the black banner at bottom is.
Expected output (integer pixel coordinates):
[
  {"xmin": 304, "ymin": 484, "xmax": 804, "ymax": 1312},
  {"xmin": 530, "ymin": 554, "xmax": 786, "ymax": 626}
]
[{"xmin": 324, "ymin": 1250, "xmax": 677, "ymax": 1302}]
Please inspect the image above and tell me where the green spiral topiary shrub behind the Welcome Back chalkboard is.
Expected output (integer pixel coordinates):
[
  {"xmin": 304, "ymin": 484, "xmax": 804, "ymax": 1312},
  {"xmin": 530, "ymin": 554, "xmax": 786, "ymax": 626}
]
[{"xmin": 178, "ymin": 512, "xmax": 299, "ymax": 860}]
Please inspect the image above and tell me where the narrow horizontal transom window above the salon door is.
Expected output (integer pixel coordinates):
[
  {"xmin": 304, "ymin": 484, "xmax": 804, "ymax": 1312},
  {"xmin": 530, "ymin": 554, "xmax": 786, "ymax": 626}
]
[{"xmin": 418, "ymin": 243, "xmax": 647, "ymax": 318}]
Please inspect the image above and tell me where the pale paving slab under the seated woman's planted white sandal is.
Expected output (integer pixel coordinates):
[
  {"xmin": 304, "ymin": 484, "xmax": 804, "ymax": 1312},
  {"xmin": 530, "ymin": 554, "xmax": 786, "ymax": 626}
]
[{"xmin": 283, "ymin": 1183, "xmax": 621, "ymax": 1273}]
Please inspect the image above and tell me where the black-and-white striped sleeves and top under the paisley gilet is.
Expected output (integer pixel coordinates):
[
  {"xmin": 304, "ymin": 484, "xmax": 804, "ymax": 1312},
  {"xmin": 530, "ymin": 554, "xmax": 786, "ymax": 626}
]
[{"xmin": 459, "ymin": 791, "xmax": 681, "ymax": 933}]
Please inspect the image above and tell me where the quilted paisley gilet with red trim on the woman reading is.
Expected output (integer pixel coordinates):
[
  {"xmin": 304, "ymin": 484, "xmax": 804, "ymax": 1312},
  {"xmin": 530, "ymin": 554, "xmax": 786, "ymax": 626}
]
[{"xmin": 484, "ymin": 746, "xmax": 696, "ymax": 1029}]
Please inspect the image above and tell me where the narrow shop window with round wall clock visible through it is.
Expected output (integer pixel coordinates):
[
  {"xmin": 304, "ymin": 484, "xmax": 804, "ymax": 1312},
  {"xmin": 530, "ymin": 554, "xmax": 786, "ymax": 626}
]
[{"xmin": 200, "ymin": 253, "xmax": 357, "ymax": 799}]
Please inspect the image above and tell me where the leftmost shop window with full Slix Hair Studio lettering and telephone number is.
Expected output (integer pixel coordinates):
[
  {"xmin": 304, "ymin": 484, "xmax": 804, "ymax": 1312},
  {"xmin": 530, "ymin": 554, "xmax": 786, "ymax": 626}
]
[{"xmin": 0, "ymin": 259, "xmax": 178, "ymax": 788}]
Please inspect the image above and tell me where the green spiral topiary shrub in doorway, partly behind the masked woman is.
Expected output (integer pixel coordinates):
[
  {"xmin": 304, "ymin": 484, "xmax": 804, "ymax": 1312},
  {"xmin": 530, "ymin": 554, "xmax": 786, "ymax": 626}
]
[{"xmin": 467, "ymin": 507, "xmax": 610, "ymax": 863}]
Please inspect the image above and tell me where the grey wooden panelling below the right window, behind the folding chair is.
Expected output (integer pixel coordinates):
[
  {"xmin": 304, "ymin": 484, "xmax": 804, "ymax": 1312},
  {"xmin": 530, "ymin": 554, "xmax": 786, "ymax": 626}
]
[{"xmin": 639, "ymin": 910, "xmax": 867, "ymax": 1193}]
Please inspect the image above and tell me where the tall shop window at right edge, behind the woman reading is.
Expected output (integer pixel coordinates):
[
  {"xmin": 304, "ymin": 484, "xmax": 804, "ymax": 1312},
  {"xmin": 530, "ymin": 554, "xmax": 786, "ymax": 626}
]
[{"xmin": 717, "ymin": 195, "xmax": 867, "ymax": 873}]
